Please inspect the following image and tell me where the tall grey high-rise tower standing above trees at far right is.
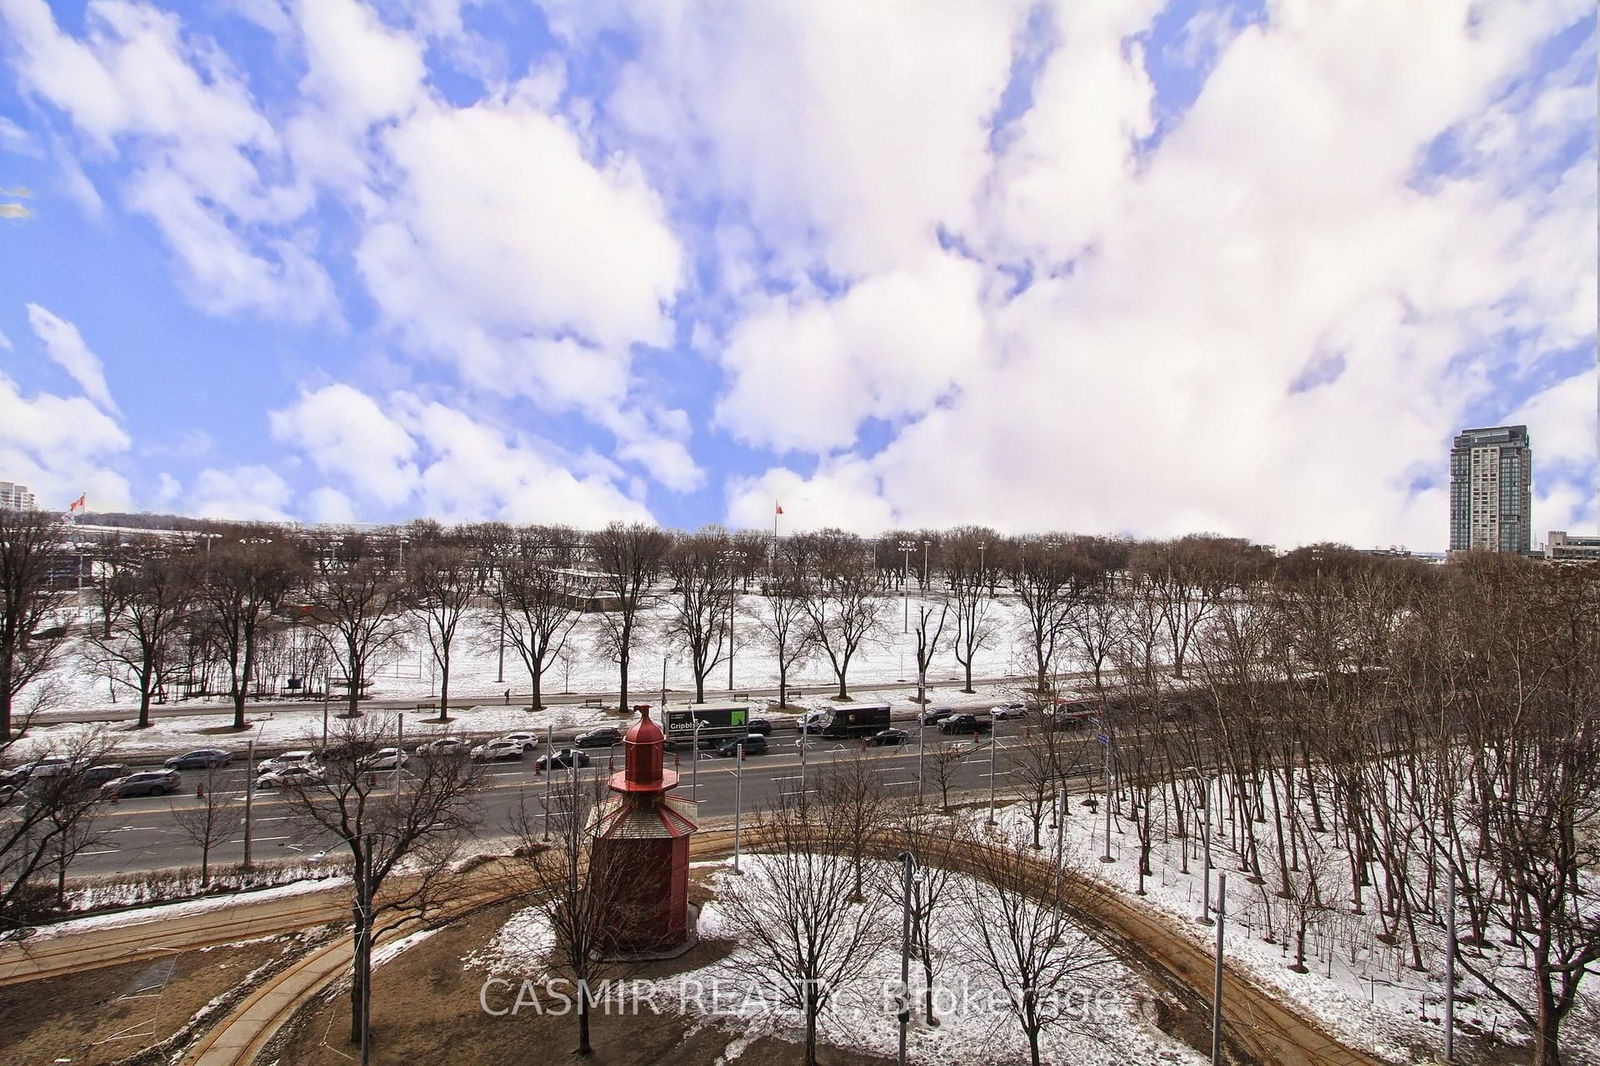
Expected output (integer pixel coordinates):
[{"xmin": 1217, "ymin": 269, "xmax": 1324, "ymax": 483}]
[{"xmin": 1450, "ymin": 426, "xmax": 1533, "ymax": 552}]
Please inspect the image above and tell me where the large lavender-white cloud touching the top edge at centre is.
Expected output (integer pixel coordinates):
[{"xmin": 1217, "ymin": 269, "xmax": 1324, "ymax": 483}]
[{"xmin": 598, "ymin": 0, "xmax": 1026, "ymax": 277}]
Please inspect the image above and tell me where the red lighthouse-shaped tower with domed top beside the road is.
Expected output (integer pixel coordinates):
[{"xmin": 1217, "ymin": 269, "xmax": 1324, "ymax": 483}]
[{"xmin": 594, "ymin": 704, "xmax": 698, "ymax": 952}]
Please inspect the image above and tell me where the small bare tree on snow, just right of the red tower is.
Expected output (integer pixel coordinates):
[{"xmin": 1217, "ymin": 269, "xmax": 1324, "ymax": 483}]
[{"xmin": 722, "ymin": 802, "xmax": 890, "ymax": 1066}]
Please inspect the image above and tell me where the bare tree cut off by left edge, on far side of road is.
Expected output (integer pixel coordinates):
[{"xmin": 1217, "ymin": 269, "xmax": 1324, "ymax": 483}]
[{"xmin": 0, "ymin": 509, "xmax": 69, "ymax": 743}]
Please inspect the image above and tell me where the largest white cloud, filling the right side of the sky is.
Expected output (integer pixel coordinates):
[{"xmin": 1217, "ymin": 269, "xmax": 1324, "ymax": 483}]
[{"xmin": 716, "ymin": 0, "xmax": 1595, "ymax": 547}]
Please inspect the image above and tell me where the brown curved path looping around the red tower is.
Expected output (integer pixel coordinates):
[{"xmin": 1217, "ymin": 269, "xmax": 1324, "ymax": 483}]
[{"xmin": 0, "ymin": 829, "xmax": 1381, "ymax": 1066}]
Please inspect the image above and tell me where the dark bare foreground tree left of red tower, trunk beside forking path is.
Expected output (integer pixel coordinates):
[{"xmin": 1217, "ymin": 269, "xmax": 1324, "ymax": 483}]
[{"xmin": 283, "ymin": 717, "xmax": 482, "ymax": 1044}]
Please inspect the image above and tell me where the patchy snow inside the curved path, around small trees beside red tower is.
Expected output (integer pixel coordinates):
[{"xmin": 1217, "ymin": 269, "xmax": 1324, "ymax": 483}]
[{"xmin": 466, "ymin": 855, "xmax": 1206, "ymax": 1066}]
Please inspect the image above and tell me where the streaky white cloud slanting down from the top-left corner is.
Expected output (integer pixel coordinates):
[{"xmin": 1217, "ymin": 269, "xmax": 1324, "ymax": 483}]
[{"xmin": 0, "ymin": 0, "xmax": 333, "ymax": 320}]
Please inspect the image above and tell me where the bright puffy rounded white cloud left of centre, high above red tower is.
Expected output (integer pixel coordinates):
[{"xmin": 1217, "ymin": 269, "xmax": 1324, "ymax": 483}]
[{"xmin": 358, "ymin": 99, "xmax": 683, "ymax": 359}]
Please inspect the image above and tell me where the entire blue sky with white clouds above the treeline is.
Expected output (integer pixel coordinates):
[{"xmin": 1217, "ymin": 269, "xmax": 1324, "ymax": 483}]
[{"xmin": 0, "ymin": 0, "xmax": 1600, "ymax": 549}]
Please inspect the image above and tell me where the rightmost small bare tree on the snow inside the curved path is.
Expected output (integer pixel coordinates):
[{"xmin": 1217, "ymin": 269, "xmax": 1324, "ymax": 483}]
[{"xmin": 955, "ymin": 845, "xmax": 1110, "ymax": 1066}]
